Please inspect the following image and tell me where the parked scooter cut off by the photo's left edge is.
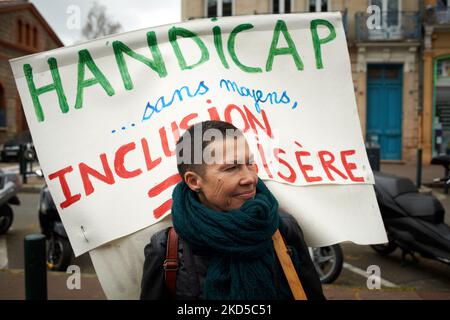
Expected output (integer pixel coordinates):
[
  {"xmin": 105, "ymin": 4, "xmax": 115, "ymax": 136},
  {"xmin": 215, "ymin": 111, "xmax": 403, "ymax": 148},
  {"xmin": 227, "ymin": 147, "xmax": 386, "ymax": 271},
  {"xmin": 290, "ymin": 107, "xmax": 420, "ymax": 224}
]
[{"xmin": 0, "ymin": 170, "xmax": 20, "ymax": 234}]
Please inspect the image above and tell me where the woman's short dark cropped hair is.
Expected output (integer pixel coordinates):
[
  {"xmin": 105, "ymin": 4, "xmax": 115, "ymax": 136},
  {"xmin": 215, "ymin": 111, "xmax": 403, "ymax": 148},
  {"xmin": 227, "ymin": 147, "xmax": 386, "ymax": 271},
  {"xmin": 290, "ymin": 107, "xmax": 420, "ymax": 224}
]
[{"xmin": 176, "ymin": 120, "xmax": 242, "ymax": 180}]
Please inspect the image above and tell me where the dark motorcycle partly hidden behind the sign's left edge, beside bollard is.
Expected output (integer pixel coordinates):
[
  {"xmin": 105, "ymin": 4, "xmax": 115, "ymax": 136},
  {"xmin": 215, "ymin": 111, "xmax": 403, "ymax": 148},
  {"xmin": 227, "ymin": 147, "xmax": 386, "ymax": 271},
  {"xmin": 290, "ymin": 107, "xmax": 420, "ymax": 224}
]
[{"xmin": 36, "ymin": 170, "xmax": 74, "ymax": 271}]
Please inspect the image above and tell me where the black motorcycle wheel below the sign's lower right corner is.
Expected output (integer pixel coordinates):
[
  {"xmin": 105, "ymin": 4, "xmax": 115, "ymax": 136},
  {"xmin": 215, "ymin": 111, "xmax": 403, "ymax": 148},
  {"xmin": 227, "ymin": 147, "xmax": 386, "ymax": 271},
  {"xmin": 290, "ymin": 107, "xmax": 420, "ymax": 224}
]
[{"xmin": 308, "ymin": 244, "xmax": 344, "ymax": 283}]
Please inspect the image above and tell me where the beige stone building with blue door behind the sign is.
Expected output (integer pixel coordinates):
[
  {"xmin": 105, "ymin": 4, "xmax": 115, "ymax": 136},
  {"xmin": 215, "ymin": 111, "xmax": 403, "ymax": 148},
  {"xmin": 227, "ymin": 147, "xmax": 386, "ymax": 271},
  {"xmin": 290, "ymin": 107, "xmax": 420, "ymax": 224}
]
[{"xmin": 182, "ymin": 0, "xmax": 450, "ymax": 163}]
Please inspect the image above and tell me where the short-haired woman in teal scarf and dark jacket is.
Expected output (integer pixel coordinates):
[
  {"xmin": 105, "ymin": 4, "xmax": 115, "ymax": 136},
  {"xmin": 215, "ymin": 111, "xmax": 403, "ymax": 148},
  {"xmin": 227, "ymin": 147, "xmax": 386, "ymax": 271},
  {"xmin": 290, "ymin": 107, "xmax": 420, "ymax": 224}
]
[{"xmin": 141, "ymin": 121, "xmax": 325, "ymax": 300}]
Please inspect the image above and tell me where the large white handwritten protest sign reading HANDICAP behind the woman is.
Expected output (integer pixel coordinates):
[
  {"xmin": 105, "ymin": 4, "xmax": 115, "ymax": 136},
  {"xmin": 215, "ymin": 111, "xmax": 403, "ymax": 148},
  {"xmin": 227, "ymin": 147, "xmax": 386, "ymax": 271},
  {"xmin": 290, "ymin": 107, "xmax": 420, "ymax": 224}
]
[{"xmin": 11, "ymin": 13, "xmax": 387, "ymax": 298}]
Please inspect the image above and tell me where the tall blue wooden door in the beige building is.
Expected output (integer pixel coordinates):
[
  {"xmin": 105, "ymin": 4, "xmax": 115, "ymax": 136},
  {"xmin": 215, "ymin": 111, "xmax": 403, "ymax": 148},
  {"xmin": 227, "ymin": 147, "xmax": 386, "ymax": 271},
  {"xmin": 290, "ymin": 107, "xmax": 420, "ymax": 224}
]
[{"xmin": 366, "ymin": 65, "xmax": 403, "ymax": 160}]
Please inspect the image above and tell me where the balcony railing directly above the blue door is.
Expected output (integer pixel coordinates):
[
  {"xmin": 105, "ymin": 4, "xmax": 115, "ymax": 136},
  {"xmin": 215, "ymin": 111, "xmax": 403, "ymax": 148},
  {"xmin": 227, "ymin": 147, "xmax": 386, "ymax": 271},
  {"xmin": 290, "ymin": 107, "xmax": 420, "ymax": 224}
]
[{"xmin": 355, "ymin": 11, "xmax": 421, "ymax": 42}]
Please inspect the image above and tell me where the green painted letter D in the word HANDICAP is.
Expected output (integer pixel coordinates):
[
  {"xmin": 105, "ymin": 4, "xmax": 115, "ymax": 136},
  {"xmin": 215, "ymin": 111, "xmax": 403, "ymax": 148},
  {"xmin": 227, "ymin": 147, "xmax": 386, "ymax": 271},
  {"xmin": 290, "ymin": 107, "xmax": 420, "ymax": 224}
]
[{"xmin": 169, "ymin": 27, "xmax": 209, "ymax": 70}]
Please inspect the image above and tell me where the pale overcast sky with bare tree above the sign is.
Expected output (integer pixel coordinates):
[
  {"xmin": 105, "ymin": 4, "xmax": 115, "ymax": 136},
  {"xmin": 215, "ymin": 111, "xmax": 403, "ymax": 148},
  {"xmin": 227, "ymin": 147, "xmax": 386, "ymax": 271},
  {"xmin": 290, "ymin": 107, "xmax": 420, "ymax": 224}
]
[{"xmin": 30, "ymin": 0, "xmax": 181, "ymax": 45}]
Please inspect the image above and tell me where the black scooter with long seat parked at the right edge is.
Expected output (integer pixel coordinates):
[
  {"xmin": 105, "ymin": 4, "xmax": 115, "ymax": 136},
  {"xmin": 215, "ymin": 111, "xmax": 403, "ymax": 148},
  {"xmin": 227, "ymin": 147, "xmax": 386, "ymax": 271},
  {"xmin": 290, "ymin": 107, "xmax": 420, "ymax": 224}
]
[{"xmin": 371, "ymin": 171, "xmax": 450, "ymax": 266}]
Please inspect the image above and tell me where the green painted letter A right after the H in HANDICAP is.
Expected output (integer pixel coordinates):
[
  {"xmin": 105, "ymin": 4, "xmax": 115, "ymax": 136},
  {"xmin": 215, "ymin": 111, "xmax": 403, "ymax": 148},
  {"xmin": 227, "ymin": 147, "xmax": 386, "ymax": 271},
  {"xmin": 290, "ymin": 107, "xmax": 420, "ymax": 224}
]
[{"xmin": 75, "ymin": 49, "xmax": 114, "ymax": 109}]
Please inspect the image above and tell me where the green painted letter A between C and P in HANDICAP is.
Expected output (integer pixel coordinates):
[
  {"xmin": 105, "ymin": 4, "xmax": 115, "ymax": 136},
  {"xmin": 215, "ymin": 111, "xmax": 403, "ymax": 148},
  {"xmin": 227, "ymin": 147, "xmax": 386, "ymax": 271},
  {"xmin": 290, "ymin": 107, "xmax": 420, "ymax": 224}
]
[{"xmin": 266, "ymin": 20, "xmax": 303, "ymax": 71}]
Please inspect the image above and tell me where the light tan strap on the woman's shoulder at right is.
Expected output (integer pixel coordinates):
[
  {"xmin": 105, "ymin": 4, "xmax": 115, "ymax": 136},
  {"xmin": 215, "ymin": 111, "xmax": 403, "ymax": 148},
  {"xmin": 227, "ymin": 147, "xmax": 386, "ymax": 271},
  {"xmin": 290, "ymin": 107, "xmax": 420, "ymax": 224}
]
[{"xmin": 272, "ymin": 229, "xmax": 308, "ymax": 300}]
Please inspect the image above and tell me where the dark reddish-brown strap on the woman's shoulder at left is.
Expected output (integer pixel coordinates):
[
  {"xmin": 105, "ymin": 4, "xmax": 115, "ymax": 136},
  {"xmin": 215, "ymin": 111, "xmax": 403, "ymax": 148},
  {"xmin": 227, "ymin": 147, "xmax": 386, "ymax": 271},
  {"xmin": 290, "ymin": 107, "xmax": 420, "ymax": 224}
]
[{"xmin": 163, "ymin": 227, "xmax": 178, "ymax": 297}]
